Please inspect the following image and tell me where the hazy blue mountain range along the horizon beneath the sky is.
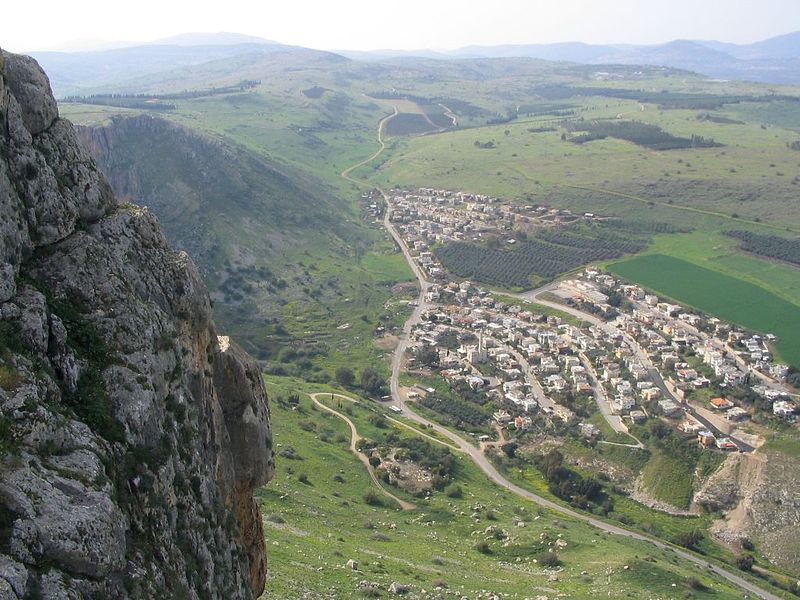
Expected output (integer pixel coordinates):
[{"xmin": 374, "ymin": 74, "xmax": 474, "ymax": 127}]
[{"xmin": 31, "ymin": 32, "xmax": 800, "ymax": 97}]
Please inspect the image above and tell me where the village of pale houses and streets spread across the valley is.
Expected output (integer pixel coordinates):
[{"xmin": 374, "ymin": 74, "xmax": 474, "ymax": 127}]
[{"xmin": 384, "ymin": 189, "xmax": 796, "ymax": 452}]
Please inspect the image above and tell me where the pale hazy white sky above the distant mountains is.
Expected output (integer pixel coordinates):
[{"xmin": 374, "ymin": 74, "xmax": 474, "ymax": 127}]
[{"xmin": 0, "ymin": 0, "xmax": 800, "ymax": 51}]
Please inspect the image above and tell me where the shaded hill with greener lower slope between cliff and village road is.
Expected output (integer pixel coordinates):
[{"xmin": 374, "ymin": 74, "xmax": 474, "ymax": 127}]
[{"xmin": 76, "ymin": 116, "xmax": 410, "ymax": 378}]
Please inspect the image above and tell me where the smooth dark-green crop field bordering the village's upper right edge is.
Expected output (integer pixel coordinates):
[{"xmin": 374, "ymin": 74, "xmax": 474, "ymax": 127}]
[{"xmin": 609, "ymin": 254, "xmax": 800, "ymax": 366}]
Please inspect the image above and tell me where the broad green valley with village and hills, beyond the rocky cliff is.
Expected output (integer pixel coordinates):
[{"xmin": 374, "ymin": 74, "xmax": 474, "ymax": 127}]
[{"xmin": 53, "ymin": 36, "xmax": 800, "ymax": 598}]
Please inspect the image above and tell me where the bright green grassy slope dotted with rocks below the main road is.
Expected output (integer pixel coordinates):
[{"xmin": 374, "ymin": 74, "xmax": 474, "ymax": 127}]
[{"xmin": 258, "ymin": 379, "xmax": 756, "ymax": 599}]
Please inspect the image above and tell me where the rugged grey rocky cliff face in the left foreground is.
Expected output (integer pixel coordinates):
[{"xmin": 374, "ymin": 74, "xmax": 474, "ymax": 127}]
[{"xmin": 0, "ymin": 53, "xmax": 273, "ymax": 599}]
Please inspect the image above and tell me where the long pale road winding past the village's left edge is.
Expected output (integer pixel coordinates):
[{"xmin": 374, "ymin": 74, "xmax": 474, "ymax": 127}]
[{"xmin": 334, "ymin": 113, "xmax": 781, "ymax": 600}]
